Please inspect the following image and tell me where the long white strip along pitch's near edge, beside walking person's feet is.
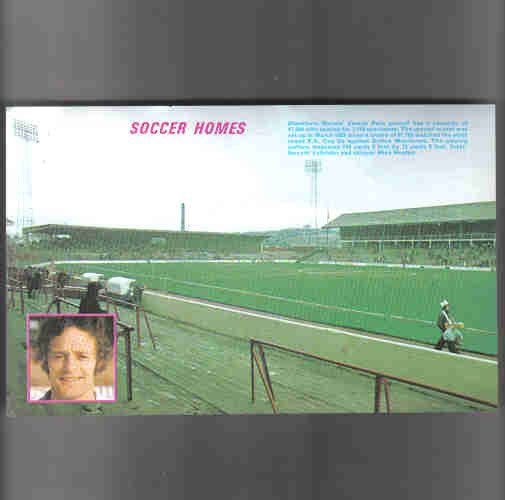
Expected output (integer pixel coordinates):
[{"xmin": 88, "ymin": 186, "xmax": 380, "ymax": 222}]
[{"xmin": 144, "ymin": 291, "xmax": 498, "ymax": 365}]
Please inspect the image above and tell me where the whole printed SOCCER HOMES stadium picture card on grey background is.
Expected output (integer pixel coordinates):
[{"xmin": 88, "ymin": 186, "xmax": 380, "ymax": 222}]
[{"xmin": 4, "ymin": 105, "xmax": 498, "ymax": 417}]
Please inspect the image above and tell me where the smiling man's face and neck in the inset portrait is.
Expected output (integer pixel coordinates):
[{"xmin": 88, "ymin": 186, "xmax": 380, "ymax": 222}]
[{"xmin": 47, "ymin": 326, "xmax": 97, "ymax": 400}]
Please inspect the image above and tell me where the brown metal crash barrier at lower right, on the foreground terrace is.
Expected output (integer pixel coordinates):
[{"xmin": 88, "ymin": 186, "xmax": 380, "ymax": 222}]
[{"xmin": 249, "ymin": 339, "xmax": 498, "ymax": 414}]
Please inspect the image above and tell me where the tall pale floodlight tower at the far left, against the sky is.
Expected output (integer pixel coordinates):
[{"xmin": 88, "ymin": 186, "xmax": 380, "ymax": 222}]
[{"xmin": 14, "ymin": 119, "xmax": 39, "ymax": 233}]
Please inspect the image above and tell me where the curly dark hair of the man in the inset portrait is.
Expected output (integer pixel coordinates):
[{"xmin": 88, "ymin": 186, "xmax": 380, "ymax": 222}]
[{"xmin": 33, "ymin": 316, "xmax": 114, "ymax": 373}]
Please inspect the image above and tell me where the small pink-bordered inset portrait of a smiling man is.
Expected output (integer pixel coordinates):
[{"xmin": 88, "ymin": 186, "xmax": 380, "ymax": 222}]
[{"xmin": 27, "ymin": 314, "xmax": 117, "ymax": 403}]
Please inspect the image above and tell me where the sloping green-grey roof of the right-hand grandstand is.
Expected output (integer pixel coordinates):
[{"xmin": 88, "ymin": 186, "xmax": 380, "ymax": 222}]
[{"xmin": 325, "ymin": 201, "xmax": 496, "ymax": 228}]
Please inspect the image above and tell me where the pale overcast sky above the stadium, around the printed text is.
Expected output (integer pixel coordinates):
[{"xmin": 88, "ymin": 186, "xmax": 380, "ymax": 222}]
[{"xmin": 6, "ymin": 105, "xmax": 496, "ymax": 232}]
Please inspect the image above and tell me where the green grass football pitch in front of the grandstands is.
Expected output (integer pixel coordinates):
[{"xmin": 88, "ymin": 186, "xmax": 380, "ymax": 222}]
[{"xmin": 61, "ymin": 262, "xmax": 497, "ymax": 355}]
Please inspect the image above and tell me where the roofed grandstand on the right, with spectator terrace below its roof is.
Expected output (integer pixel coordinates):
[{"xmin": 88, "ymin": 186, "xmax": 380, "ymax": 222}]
[{"xmin": 325, "ymin": 202, "xmax": 496, "ymax": 267}]
